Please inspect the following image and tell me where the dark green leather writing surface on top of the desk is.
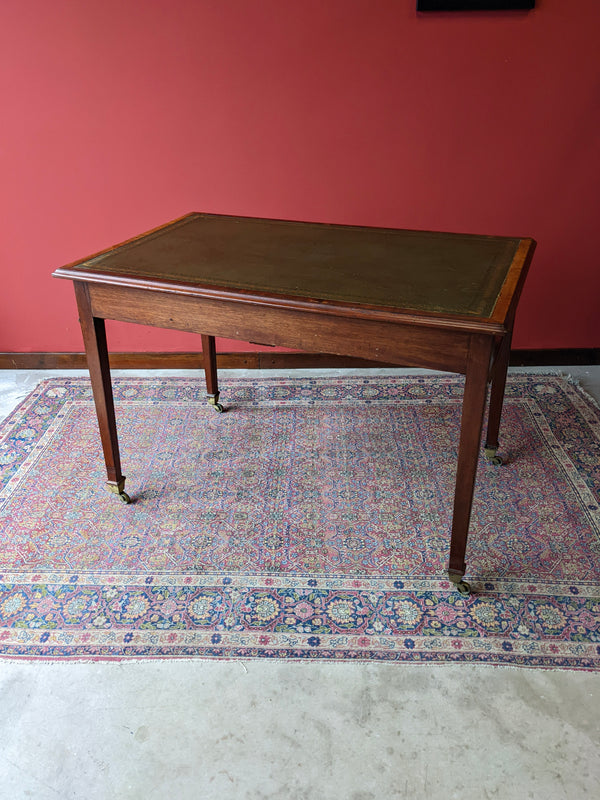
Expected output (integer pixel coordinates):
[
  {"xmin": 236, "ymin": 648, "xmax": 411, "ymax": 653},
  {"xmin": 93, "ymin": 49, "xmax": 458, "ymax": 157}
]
[{"xmin": 67, "ymin": 214, "xmax": 521, "ymax": 318}]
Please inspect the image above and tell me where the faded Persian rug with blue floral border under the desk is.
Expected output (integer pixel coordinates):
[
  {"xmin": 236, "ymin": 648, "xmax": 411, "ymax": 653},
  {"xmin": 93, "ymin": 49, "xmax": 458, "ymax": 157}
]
[{"xmin": 0, "ymin": 375, "xmax": 600, "ymax": 670}]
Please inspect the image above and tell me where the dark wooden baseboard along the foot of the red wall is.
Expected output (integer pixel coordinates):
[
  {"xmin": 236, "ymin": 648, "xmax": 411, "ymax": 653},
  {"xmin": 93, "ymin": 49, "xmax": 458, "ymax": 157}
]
[{"xmin": 0, "ymin": 347, "xmax": 600, "ymax": 370}]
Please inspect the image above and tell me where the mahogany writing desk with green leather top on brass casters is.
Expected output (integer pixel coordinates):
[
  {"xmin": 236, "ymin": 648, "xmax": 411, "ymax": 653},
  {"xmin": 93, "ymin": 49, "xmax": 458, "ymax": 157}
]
[{"xmin": 54, "ymin": 214, "xmax": 535, "ymax": 593}]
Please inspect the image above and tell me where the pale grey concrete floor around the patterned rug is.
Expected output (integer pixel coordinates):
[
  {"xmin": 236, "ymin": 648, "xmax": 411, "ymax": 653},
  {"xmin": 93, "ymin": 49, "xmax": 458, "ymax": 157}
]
[{"xmin": 0, "ymin": 367, "xmax": 600, "ymax": 800}]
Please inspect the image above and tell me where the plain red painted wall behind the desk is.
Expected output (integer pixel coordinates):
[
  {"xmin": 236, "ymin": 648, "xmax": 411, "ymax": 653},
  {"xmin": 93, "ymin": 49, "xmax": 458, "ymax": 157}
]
[{"xmin": 0, "ymin": 0, "xmax": 600, "ymax": 352}]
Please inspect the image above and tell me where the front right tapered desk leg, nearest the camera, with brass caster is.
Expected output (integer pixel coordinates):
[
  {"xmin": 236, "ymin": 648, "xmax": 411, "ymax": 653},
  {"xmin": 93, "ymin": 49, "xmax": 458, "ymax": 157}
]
[{"xmin": 448, "ymin": 336, "xmax": 493, "ymax": 594}]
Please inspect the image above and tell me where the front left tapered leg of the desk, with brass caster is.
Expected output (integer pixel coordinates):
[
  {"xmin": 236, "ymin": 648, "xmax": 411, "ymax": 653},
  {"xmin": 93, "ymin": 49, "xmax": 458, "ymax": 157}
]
[{"xmin": 74, "ymin": 281, "xmax": 130, "ymax": 503}]
